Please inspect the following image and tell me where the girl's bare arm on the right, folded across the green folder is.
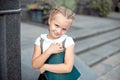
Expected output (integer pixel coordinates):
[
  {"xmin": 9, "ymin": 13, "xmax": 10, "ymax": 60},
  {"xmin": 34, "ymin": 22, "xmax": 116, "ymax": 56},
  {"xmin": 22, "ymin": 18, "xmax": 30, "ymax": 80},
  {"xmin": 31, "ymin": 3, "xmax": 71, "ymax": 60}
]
[{"xmin": 40, "ymin": 45, "xmax": 74, "ymax": 73}]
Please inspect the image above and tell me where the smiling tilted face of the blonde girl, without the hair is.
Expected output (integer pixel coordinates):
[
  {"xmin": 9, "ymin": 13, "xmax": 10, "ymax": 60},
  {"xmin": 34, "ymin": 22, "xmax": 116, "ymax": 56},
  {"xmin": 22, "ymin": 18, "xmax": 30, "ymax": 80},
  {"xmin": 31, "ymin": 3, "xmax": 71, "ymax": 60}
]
[{"xmin": 48, "ymin": 13, "xmax": 72, "ymax": 39}]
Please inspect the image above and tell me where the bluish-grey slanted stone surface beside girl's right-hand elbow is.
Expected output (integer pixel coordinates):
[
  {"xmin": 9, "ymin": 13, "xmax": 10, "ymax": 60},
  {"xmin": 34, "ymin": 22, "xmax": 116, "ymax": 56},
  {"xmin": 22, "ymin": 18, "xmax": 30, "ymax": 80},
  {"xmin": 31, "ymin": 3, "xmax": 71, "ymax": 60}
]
[{"xmin": 75, "ymin": 55, "xmax": 98, "ymax": 80}]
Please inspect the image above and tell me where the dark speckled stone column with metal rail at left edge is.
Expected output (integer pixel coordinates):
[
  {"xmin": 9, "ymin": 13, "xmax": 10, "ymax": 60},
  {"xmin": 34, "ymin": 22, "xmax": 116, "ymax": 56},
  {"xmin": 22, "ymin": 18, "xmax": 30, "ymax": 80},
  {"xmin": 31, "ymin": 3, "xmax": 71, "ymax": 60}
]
[{"xmin": 0, "ymin": 0, "xmax": 21, "ymax": 80}]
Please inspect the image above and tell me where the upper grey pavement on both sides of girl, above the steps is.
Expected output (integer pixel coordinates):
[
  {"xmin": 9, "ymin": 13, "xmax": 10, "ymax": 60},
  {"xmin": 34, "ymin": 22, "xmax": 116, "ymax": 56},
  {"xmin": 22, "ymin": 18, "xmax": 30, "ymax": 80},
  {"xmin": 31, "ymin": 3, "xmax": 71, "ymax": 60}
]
[{"xmin": 21, "ymin": 13, "xmax": 120, "ymax": 80}]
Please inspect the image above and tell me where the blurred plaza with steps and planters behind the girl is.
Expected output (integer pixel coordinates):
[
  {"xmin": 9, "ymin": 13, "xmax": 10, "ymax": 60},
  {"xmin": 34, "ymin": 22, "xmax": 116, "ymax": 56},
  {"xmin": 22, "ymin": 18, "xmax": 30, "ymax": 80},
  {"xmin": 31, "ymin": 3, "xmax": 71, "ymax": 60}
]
[{"xmin": 21, "ymin": 0, "xmax": 120, "ymax": 80}]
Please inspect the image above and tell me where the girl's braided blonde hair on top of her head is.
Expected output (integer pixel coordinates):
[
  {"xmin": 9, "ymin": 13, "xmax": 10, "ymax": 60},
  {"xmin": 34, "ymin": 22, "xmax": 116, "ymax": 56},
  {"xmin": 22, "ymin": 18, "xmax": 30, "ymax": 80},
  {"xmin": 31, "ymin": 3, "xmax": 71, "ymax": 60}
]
[{"xmin": 49, "ymin": 6, "xmax": 75, "ymax": 20}]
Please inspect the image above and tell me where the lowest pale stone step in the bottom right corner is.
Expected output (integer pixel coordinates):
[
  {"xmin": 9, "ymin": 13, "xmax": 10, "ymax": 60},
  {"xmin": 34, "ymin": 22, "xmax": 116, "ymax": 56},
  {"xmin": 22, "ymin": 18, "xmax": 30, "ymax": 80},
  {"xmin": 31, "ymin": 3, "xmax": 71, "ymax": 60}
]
[{"xmin": 97, "ymin": 65, "xmax": 120, "ymax": 80}]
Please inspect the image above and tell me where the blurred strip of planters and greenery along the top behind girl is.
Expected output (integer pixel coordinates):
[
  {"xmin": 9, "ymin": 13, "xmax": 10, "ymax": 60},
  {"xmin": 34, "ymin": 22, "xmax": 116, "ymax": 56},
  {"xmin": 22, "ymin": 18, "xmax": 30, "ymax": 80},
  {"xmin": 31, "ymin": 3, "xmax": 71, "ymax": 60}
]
[{"xmin": 21, "ymin": 0, "xmax": 120, "ymax": 23}]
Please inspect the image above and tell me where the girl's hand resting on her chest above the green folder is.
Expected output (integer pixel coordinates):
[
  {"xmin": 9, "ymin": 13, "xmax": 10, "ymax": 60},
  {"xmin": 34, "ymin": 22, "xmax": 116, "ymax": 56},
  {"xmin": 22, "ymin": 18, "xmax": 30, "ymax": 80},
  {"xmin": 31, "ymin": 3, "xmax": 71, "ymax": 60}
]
[{"xmin": 48, "ymin": 43, "xmax": 64, "ymax": 54}]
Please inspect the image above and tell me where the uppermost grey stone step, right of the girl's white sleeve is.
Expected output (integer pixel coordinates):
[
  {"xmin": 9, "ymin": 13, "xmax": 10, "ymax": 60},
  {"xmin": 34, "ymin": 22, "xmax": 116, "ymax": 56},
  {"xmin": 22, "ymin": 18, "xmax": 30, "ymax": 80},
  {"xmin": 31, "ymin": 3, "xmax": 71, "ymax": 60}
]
[{"xmin": 75, "ymin": 29, "xmax": 120, "ymax": 54}]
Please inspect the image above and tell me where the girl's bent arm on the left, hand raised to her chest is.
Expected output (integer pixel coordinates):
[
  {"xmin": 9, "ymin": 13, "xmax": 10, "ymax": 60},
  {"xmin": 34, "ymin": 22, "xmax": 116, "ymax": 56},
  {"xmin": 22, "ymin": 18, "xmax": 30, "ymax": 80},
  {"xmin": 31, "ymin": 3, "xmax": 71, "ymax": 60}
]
[{"xmin": 32, "ymin": 43, "xmax": 64, "ymax": 69}]
